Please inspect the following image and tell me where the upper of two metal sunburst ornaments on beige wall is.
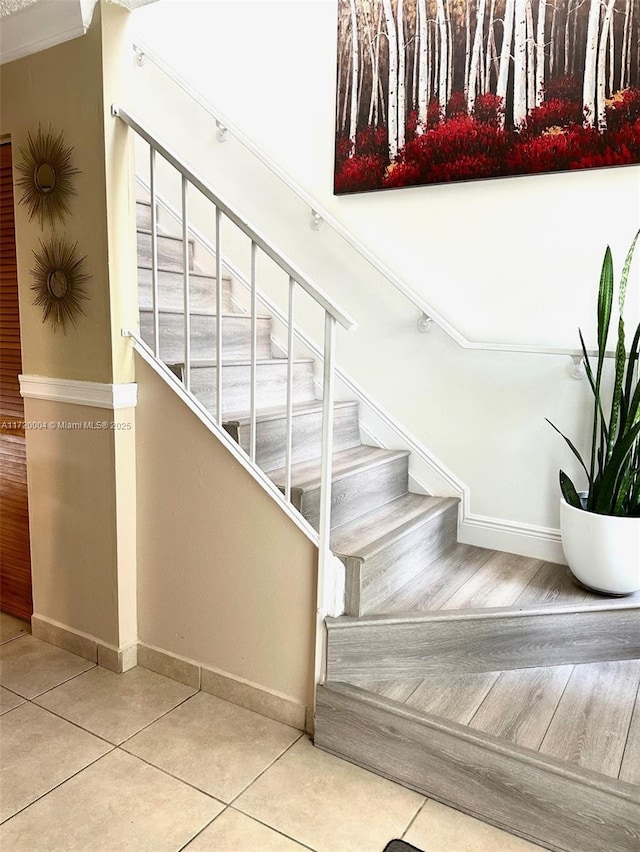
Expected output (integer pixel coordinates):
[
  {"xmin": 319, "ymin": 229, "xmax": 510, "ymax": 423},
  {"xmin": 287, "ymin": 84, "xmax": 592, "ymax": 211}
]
[{"xmin": 16, "ymin": 126, "xmax": 80, "ymax": 228}]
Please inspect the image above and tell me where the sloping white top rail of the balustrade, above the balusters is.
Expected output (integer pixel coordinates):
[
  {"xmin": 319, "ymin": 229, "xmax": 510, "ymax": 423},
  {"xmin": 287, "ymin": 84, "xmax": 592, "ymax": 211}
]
[{"xmin": 111, "ymin": 104, "xmax": 358, "ymax": 331}]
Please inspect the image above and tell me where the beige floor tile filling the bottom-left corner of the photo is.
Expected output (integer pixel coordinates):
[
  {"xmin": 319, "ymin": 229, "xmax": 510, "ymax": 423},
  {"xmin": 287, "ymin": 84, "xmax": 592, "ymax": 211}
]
[{"xmin": 0, "ymin": 749, "xmax": 223, "ymax": 852}]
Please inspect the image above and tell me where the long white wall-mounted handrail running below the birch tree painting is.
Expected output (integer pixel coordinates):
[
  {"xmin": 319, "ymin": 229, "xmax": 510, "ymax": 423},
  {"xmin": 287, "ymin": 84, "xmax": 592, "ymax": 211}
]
[{"xmin": 133, "ymin": 39, "xmax": 604, "ymax": 363}]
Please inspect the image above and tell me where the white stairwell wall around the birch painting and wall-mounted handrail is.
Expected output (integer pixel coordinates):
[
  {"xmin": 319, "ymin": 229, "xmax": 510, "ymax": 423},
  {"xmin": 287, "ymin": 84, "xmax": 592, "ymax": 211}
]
[{"xmin": 132, "ymin": 0, "xmax": 640, "ymax": 557}]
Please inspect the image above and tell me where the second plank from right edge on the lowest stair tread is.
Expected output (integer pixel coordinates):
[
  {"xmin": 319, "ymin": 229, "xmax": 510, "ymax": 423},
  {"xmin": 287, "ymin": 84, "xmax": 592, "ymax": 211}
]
[{"xmin": 540, "ymin": 660, "xmax": 640, "ymax": 778}]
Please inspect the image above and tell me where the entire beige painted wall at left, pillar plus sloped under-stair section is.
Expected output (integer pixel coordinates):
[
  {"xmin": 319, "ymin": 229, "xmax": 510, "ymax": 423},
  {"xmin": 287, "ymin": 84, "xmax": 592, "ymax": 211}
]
[{"xmin": 0, "ymin": 3, "xmax": 317, "ymax": 706}]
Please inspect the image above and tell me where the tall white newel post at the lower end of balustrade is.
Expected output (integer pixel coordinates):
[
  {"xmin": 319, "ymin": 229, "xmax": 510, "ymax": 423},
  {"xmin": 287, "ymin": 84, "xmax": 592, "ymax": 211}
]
[{"xmin": 315, "ymin": 311, "xmax": 336, "ymax": 683}]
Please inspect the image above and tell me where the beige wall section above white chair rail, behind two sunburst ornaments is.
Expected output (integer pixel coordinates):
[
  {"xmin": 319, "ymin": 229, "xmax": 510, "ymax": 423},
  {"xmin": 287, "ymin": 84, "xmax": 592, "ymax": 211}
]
[{"xmin": 0, "ymin": 7, "xmax": 113, "ymax": 382}]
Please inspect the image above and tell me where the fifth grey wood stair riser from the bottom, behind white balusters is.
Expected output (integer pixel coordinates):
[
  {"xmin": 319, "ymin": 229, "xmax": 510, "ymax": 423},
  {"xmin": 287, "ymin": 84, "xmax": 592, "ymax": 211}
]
[{"xmin": 225, "ymin": 406, "xmax": 360, "ymax": 470}]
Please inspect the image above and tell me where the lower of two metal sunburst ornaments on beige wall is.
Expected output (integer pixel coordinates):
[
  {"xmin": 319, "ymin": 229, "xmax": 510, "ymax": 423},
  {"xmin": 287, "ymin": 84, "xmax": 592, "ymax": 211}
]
[{"xmin": 31, "ymin": 237, "xmax": 90, "ymax": 334}]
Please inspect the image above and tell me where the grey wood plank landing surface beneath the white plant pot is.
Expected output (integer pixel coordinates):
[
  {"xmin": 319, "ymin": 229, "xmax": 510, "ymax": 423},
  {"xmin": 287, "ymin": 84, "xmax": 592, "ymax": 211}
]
[{"xmin": 367, "ymin": 544, "xmax": 640, "ymax": 615}]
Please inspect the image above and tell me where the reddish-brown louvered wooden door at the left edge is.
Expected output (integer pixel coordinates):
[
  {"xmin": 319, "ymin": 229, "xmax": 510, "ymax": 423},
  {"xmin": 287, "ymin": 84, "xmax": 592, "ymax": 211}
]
[{"xmin": 0, "ymin": 144, "xmax": 33, "ymax": 619}]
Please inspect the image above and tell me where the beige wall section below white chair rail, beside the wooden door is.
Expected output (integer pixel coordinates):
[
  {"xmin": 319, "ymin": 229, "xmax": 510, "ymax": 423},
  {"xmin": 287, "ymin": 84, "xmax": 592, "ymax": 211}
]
[{"xmin": 25, "ymin": 399, "xmax": 135, "ymax": 647}]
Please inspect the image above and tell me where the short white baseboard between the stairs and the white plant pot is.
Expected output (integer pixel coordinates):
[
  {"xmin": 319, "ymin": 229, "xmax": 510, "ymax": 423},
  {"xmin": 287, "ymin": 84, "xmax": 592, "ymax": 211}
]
[{"xmin": 458, "ymin": 515, "xmax": 566, "ymax": 565}]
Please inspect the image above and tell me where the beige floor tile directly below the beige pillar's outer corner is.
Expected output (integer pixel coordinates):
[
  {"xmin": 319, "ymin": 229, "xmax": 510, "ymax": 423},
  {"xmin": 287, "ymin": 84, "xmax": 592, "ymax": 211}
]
[{"xmin": 36, "ymin": 666, "xmax": 195, "ymax": 745}]
